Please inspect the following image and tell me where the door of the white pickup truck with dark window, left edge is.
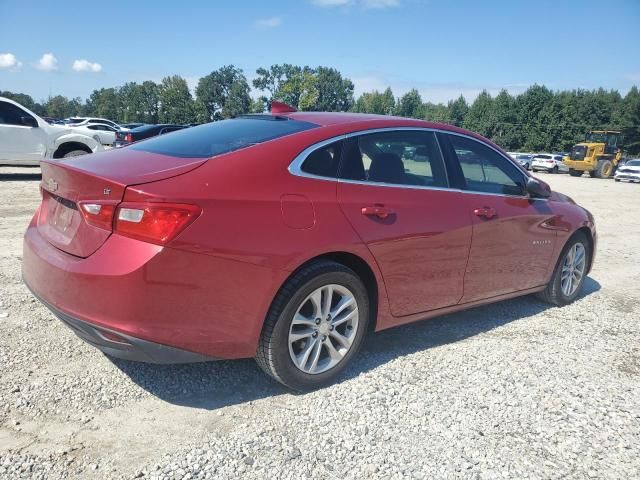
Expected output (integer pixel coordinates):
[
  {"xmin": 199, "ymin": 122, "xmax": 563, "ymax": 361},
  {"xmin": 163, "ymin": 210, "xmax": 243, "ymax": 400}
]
[{"xmin": 0, "ymin": 100, "xmax": 47, "ymax": 165}]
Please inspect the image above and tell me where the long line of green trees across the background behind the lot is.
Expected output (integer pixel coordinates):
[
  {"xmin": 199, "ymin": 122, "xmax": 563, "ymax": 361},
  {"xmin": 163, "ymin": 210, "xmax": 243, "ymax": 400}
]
[{"xmin": 0, "ymin": 64, "xmax": 640, "ymax": 154}]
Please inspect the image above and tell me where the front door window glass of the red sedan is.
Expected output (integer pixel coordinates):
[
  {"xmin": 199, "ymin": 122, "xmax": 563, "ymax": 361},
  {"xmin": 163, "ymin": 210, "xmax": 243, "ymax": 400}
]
[{"xmin": 449, "ymin": 135, "xmax": 525, "ymax": 195}]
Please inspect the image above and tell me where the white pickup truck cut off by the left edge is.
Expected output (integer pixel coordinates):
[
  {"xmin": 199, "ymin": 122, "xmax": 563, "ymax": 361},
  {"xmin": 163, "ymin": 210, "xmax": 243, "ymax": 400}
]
[{"xmin": 0, "ymin": 97, "xmax": 104, "ymax": 165}]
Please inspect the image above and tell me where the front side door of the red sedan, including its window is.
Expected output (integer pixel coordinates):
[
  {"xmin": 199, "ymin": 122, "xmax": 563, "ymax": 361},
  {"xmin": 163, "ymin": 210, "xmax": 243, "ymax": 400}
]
[{"xmin": 439, "ymin": 134, "xmax": 556, "ymax": 303}]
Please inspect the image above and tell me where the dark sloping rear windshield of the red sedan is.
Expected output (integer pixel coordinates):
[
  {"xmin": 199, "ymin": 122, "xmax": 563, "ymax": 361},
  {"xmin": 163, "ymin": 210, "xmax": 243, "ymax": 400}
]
[{"xmin": 130, "ymin": 117, "xmax": 317, "ymax": 158}]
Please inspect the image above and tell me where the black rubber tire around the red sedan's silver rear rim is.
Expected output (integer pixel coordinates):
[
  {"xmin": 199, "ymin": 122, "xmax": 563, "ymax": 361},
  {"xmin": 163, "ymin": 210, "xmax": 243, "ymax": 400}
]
[{"xmin": 256, "ymin": 260, "xmax": 370, "ymax": 391}]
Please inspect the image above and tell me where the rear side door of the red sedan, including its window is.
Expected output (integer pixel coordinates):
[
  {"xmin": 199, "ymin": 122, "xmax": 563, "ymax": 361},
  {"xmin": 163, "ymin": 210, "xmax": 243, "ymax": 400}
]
[{"xmin": 337, "ymin": 129, "xmax": 471, "ymax": 317}]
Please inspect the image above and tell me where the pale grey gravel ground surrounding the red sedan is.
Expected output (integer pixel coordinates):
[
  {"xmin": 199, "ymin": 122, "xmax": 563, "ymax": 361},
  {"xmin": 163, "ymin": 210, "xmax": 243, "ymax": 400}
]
[{"xmin": 0, "ymin": 167, "xmax": 640, "ymax": 479}]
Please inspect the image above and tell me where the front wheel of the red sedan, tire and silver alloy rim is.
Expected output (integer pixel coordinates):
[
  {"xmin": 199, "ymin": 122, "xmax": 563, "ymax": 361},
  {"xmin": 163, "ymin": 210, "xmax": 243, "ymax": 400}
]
[{"xmin": 539, "ymin": 232, "xmax": 590, "ymax": 305}]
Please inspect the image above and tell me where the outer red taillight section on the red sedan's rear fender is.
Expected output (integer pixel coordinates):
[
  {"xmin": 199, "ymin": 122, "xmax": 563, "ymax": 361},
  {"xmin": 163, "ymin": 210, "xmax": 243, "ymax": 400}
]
[{"xmin": 114, "ymin": 203, "xmax": 202, "ymax": 245}]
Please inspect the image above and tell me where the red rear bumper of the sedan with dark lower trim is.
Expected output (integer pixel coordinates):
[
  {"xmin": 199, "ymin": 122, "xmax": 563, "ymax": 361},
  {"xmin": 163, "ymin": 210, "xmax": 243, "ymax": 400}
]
[{"xmin": 22, "ymin": 214, "xmax": 286, "ymax": 363}]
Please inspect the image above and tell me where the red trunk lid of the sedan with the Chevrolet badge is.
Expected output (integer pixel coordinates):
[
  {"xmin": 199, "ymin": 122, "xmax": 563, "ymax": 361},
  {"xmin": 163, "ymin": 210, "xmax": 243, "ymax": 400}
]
[{"xmin": 38, "ymin": 149, "xmax": 206, "ymax": 257}]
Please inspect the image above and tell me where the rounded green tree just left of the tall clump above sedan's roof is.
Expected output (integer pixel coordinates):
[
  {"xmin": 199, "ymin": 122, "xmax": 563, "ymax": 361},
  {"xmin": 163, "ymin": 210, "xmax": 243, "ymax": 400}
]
[{"xmin": 196, "ymin": 65, "xmax": 251, "ymax": 121}]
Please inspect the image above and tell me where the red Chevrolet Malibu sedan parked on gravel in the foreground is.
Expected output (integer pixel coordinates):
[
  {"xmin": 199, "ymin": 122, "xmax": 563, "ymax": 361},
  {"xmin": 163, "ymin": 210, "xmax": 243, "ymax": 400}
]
[{"xmin": 23, "ymin": 105, "xmax": 596, "ymax": 390}]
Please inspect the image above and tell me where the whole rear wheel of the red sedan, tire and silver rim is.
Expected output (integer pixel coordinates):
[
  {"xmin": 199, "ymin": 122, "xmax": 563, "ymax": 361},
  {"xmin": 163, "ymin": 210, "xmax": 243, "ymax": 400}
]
[{"xmin": 256, "ymin": 260, "xmax": 369, "ymax": 391}]
